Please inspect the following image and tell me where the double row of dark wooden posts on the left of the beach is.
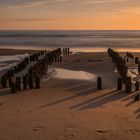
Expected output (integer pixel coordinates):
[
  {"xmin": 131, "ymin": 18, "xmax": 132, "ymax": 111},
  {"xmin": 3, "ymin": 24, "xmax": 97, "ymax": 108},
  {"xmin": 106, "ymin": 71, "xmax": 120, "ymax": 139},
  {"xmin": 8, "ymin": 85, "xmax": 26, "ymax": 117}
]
[{"xmin": 1, "ymin": 48, "xmax": 62, "ymax": 93}]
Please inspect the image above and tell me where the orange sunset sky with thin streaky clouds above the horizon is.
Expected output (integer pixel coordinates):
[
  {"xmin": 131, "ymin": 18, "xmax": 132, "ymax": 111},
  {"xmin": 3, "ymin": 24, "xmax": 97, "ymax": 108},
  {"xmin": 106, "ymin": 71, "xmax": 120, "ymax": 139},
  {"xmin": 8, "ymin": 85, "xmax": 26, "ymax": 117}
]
[{"xmin": 0, "ymin": 0, "xmax": 140, "ymax": 30}]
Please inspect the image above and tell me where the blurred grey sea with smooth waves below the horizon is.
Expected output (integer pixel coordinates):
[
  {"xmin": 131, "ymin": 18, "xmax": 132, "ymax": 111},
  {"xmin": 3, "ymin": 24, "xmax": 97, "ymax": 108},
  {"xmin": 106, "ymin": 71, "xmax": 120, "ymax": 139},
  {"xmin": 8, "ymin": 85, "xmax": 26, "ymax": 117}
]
[{"xmin": 0, "ymin": 30, "xmax": 140, "ymax": 52}]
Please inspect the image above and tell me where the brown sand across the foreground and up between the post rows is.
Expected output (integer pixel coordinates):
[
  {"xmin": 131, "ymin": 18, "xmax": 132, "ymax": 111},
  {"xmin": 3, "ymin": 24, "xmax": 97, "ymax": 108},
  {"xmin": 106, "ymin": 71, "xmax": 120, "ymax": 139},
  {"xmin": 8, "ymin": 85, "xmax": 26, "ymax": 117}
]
[{"xmin": 0, "ymin": 50, "xmax": 140, "ymax": 140}]
